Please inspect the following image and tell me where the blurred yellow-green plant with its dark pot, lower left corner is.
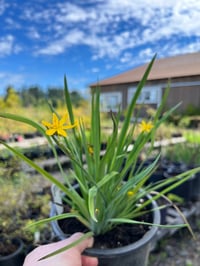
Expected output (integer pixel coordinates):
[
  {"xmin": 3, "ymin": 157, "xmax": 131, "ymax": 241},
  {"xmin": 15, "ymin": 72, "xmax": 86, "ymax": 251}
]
[{"xmin": 0, "ymin": 176, "xmax": 51, "ymax": 266}]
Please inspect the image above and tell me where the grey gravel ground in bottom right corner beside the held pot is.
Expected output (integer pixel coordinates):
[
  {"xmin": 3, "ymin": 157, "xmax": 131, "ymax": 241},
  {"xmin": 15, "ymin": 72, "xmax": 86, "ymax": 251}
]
[{"xmin": 148, "ymin": 216, "xmax": 200, "ymax": 266}]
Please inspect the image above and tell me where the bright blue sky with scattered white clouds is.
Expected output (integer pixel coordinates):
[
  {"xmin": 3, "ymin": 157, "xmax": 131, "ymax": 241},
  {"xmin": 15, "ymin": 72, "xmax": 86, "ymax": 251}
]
[{"xmin": 0, "ymin": 0, "xmax": 200, "ymax": 93}]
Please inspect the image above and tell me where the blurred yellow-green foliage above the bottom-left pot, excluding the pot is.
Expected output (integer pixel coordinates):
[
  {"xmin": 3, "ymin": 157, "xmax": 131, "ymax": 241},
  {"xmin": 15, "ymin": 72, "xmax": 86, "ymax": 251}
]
[{"xmin": 0, "ymin": 176, "xmax": 50, "ymax": 255}]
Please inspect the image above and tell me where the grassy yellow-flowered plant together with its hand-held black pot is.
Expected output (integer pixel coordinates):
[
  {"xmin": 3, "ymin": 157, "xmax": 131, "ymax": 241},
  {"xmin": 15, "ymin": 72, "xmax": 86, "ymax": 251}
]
[{"xmin": 0, "ymin": 57, "xmax": 200, "ymax": 266}]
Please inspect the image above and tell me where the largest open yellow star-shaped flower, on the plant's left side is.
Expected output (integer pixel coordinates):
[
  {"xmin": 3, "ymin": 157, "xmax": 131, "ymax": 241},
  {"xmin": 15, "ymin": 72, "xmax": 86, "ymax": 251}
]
[{"xmin": 42, "ymin": 113, "xmax": 77, "ymax": 137}]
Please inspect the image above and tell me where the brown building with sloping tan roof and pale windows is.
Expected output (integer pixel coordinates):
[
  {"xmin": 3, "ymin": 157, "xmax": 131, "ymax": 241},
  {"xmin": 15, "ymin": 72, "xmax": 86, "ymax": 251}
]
[{"xmin": 90, "ymin": 52, "xmax": 200, "ymax": 113}]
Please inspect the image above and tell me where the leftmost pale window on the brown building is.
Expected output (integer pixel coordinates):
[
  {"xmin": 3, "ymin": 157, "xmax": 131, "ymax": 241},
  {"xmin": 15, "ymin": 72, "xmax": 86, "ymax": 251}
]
[{"xmin": 100, "ymin": 92, "xmax": 122, "ymax": 112}]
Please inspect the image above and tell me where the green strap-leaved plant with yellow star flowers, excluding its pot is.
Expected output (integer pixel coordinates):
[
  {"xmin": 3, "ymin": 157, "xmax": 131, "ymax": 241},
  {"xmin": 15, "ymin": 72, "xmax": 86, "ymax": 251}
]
[{"xmin": 0, "ymin": 55, "xmax": 200, "ymax": 256}]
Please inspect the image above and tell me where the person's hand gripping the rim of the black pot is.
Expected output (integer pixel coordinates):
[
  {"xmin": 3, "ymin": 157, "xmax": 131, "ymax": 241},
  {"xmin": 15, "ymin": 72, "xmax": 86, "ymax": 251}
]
[{"xmin": 23, "ymin": 233, "xmax": 98, "ymax": 266}]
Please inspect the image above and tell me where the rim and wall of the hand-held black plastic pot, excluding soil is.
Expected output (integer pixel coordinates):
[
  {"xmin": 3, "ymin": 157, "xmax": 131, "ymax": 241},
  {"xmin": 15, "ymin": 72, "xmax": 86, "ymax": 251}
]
[{"xmin": 50, "ymin": 185, "xmax": 160, "ymax": 266}]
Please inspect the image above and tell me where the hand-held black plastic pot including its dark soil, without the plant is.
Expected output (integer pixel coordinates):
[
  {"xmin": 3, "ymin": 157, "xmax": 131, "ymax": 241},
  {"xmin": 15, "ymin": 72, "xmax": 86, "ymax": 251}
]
[{"xmin": 51, "ymin": 202, "xmax": 160, "ymax": 266}]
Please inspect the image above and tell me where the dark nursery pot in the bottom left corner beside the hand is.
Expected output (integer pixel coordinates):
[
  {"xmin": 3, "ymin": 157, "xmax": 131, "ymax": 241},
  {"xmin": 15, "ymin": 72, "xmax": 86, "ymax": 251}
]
[{"xmin": 0, "ymin": 238, "xmax": 25, "ymax": 266}]
